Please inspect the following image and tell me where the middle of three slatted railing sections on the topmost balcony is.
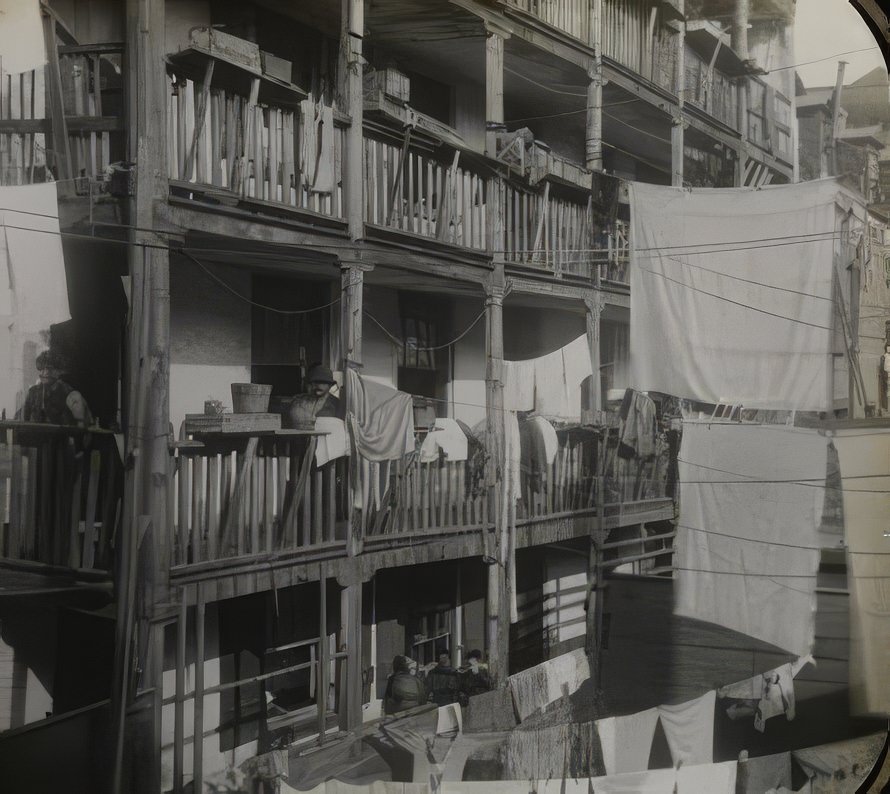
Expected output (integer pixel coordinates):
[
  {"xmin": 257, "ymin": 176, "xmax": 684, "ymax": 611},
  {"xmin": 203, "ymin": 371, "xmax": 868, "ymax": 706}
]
[{"xmin": 602, "ymin": 0, "xmax": 679, "ymax": 93}]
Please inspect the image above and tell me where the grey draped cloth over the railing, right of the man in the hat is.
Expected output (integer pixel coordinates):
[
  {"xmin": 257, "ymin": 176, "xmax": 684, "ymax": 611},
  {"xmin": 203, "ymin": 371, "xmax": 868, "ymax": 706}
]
[{"xmin": 346, "ymin": 369, "xmax": 414, "ymax": 461}]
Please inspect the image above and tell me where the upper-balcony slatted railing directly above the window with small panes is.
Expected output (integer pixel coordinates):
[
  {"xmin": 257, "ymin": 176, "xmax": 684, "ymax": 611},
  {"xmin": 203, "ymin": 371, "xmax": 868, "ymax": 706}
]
[{"xmin": 364, "ymin": 137, "xmax": 487, "ymax": 250}]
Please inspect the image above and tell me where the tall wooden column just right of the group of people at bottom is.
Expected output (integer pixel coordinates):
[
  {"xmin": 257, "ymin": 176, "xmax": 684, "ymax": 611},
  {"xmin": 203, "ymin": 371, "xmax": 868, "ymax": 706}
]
[{"xmin": 484, "ymin": 270, "xmax": 510, "ymax": 686}]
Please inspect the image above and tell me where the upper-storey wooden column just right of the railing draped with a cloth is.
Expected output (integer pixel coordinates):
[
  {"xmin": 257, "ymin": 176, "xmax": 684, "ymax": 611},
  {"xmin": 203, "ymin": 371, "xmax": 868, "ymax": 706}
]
[{"xmin": 340, "ymin": 0, "xmax": 365, "ymax": 240}]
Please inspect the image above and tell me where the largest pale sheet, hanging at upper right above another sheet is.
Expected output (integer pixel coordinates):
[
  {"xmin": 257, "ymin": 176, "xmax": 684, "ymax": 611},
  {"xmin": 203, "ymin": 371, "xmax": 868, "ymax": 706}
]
[{"xmin": 629, "ymin": 180, "xmax": 850, "ymax": 411}]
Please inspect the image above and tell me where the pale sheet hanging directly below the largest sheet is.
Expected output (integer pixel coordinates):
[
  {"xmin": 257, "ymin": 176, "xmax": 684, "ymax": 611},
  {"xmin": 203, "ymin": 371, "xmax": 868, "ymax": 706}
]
[{"xmin": 674, "ymin": 422, "xmax": 828, "ymax": 654}]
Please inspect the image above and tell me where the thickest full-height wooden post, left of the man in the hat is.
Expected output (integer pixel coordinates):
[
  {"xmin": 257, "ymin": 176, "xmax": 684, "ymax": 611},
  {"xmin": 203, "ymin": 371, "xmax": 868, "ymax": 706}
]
[{"xmin": 114, "ymin": 0, "xmax": 172, "ymax": 792}]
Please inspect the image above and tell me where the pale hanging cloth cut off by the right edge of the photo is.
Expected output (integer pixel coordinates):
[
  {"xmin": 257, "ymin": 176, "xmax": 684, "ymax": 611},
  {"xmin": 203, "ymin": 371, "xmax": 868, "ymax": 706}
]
[{"xmin": 833, "ymin": 429, "xmax": 890, "ymax": 715}]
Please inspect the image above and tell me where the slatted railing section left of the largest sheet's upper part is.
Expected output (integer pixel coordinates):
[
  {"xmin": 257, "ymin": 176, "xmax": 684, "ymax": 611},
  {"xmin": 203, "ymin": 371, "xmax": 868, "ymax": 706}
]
[{"xmin": 503, "ymin": 182, "xmax": 595, "ymax": 278}]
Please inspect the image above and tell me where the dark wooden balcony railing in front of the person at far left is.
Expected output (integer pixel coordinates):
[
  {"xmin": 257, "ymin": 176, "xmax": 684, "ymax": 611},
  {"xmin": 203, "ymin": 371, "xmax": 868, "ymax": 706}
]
[{"xmin": 0, "ymin": 422, "xmax": 122, "ymax": 570}]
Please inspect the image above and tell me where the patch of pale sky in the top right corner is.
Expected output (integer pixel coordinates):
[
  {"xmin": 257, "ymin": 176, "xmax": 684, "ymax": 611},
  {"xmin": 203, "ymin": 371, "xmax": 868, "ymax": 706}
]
[{"xmin": 794, "ymin": 0, "xmax": 886, "ymax": 87}]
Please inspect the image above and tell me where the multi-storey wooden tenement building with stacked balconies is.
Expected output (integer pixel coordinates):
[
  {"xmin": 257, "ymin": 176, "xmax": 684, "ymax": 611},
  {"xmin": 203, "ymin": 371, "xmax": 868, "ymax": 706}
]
[{"xmin": 0, "ymin": 0, "xmax": 876, "ymax": 792}]
